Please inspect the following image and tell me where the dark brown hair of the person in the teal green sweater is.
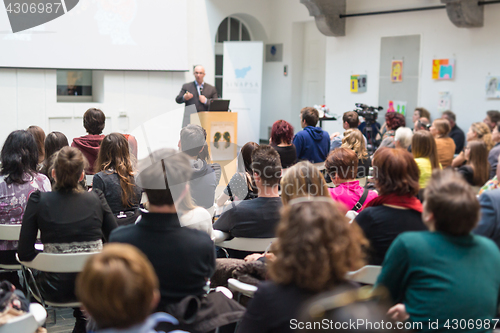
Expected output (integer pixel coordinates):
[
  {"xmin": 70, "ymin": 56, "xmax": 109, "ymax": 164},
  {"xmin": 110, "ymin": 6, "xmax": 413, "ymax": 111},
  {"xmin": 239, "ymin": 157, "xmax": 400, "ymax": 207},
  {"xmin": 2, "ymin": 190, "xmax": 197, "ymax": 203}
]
[{"xmin": 424, "ymin": 169, "xmax": 480, "ymax": 236}]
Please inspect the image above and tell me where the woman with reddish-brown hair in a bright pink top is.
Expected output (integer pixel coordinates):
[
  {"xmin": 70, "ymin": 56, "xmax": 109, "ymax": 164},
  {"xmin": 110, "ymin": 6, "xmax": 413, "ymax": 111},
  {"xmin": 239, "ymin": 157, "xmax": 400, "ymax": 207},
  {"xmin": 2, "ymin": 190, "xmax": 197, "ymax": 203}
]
[{"xmin": 325, "ymin": 148, "xmax": 377, "ymax": 212}]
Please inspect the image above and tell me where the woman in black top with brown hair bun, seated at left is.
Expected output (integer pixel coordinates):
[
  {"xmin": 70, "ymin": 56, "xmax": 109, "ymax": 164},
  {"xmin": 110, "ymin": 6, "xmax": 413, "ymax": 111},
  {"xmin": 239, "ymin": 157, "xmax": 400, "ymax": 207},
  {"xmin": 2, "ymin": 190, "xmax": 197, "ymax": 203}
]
[{"xmin": 18, "ymin": 147, "xmax": 117, "ymax": 332}]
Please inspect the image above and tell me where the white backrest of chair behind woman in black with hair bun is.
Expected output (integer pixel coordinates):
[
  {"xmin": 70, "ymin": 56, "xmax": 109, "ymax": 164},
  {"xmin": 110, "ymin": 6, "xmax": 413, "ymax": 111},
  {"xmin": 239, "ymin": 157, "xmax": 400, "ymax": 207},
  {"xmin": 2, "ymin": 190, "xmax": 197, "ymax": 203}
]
[{"xmin": 16, "ymin": 252, "xmax": 96, "ymax": 273}]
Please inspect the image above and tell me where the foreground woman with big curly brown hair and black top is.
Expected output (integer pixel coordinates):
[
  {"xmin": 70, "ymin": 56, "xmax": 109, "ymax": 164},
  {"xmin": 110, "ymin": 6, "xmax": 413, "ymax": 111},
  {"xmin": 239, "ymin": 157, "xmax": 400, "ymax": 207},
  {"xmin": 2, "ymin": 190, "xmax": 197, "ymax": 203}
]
[{"xmin": 238, "ymin": 198, "xmax": 366, "ymax": 333}]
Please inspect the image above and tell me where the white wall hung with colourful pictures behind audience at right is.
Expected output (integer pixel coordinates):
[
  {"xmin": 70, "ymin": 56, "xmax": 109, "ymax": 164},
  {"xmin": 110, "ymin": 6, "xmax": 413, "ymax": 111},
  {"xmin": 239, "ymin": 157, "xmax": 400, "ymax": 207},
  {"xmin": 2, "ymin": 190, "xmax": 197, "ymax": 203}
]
[{"xmin": 326, "ymin": 0, "xmax": 500, "ymax": 131}]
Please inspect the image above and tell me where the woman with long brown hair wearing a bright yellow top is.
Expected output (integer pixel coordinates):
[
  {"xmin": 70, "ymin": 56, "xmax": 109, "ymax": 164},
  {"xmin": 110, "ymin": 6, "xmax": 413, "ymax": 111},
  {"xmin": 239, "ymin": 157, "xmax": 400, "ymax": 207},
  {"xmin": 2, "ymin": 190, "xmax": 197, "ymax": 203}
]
[{"xmin": 412, "ymin": 131, "xmax": 441, "ymax": 190}]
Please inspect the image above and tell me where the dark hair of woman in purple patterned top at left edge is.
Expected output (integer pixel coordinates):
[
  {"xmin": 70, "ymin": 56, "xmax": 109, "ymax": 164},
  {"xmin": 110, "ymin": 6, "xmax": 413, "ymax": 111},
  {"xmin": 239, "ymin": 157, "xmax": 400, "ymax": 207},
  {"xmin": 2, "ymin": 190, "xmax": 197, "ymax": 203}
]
[{"xmin": 0, "ymin": 130, "xmax": 38, "ymax": 184}]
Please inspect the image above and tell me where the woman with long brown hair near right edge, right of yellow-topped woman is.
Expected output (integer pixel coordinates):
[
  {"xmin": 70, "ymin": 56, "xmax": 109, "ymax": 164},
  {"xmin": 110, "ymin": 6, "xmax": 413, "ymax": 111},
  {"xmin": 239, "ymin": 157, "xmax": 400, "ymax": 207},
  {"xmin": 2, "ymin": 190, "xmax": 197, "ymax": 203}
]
[{"xmin": 458, "ymin": 141, "xmax": 490, "ymax": 186}]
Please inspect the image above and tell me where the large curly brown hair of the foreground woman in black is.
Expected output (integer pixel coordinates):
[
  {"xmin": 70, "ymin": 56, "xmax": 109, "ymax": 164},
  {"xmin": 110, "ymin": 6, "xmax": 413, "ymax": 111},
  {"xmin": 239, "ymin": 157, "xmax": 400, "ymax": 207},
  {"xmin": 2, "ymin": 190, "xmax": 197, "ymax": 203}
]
[{"xmin": 269, "ymin": 198, "xmax": 368, "ymax": 292}]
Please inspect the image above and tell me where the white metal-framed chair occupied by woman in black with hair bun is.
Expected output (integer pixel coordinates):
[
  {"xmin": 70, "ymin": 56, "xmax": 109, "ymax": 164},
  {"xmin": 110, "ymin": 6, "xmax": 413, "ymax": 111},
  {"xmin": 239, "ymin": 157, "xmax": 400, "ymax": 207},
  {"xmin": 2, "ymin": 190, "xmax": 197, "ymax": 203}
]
[{"xmin": 16, "ymin": 252, "xmax": 95, "ymax": 308}]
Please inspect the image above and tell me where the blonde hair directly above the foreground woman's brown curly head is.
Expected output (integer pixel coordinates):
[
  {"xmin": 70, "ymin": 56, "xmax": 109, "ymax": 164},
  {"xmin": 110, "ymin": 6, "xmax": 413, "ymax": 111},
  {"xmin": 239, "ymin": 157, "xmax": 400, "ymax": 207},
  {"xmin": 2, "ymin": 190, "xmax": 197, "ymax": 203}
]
[{"xmin": 281, "ymin": 162, "xmax": 333, "ymax": 206}]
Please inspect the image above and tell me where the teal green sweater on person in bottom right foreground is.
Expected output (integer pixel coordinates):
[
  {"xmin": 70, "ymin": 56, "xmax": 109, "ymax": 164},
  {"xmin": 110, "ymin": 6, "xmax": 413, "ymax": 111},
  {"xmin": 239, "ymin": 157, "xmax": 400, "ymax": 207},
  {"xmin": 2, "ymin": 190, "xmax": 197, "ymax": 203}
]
[{"xmin": 376, "ymin": 231, "xmax": 500, "ymax": 332}]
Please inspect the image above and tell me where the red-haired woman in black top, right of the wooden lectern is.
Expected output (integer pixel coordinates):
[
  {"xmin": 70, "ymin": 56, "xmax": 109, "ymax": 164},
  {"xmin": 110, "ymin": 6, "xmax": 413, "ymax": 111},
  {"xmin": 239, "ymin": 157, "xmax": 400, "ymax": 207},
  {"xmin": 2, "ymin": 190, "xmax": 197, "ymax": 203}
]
[{"xmin": 269, "ymin": 120, "xmax": 297, "ymax": 169}]
